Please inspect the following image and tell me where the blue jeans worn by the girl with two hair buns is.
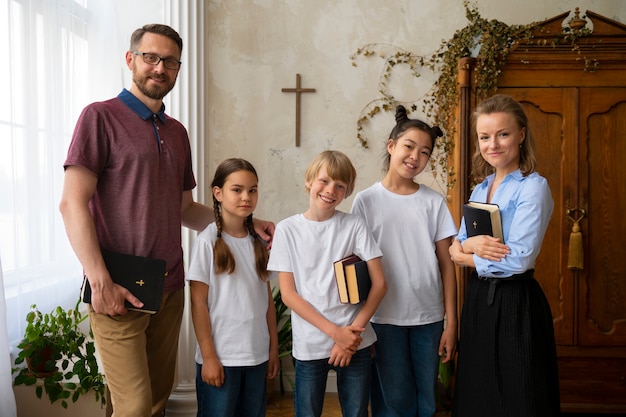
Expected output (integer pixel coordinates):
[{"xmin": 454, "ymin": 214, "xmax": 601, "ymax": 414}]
[{"xmin": 370, "ymin": 321, "xmax": 443, "ymax": 417}]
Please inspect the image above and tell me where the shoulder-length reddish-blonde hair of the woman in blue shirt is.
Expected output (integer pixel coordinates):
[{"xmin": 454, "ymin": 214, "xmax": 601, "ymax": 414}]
[{"xmin": 472, "ymin": 94, "xmax": 537, "ymax": 183}]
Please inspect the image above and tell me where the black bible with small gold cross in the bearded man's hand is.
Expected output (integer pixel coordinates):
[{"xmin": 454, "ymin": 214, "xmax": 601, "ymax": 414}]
[{"xmin": 81, "ymin": 250, "xmax": 167, "ymax": 314}]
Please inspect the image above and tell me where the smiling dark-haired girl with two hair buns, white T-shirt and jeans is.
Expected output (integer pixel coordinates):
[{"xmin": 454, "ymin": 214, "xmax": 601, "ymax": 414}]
[{"xmin": 352, "ymin": 106, "xmax": 457, "ymax": 417}]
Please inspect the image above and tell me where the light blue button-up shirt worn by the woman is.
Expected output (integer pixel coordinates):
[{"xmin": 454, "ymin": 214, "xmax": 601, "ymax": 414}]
[{"xmin": 457, "ymin": 170, "xmax": 554, "ymax": 278}]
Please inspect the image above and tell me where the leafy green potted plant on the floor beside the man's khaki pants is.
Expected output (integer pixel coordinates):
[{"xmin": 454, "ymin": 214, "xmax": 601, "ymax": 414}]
[{"xmin": 12, "ymin": 299, "xmax": 106, "ymax": 408}]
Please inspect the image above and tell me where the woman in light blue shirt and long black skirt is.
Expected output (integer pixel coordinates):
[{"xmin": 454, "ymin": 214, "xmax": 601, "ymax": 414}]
[{"xmin": 450, "ymin": 95, "xmax": 560, "ymax": 417}]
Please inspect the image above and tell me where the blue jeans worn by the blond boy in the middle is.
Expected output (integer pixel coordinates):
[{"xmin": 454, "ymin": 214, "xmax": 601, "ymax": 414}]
[{"xmin": 294, "ymin": 347, "xmax": 372, "ymax": 417}]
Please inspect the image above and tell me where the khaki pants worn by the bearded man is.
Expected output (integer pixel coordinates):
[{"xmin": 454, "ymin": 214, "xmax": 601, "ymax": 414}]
[{"xmin": 89, "ymin": 289, "xmax": 185, "ymax": 417}]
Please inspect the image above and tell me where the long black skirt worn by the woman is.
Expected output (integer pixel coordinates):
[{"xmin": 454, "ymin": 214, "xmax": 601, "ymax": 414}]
[{"xmin": 452, "ymin": 270, "xmax": 560, "ymax": 417}]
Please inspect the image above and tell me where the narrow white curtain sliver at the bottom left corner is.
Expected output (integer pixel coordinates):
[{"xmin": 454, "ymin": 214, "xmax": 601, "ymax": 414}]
[{"xmin": 0, "ymin": 258, "xmax": 17, "ymax": 417}]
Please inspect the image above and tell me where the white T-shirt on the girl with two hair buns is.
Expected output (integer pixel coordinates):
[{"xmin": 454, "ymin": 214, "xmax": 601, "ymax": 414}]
[{"xmin": 352, "ymin": 182, "xmax": 457, "ymax": 326}]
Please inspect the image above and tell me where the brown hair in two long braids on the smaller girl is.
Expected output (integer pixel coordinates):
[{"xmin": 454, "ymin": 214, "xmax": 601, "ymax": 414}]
[{"xmin": 211, "ymin": 158, "xmax": 269, "ymax": 281}]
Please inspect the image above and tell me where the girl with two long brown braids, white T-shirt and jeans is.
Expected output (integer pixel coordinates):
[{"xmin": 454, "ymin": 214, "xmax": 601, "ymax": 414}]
[{"xmin": 187, "ymin": 158, "xmax": 278, "ymax": 417}]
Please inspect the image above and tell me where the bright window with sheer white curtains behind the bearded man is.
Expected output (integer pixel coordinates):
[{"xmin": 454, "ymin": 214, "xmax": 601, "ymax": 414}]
[{"xmin": 0, "ymin": 0, "xmax": 125, "ymax": 352}]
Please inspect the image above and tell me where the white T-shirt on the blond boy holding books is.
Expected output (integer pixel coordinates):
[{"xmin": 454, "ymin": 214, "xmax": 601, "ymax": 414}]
[{"xmin": 267, "ymin": 211, "xmax": 381, "ymax": 360}]
